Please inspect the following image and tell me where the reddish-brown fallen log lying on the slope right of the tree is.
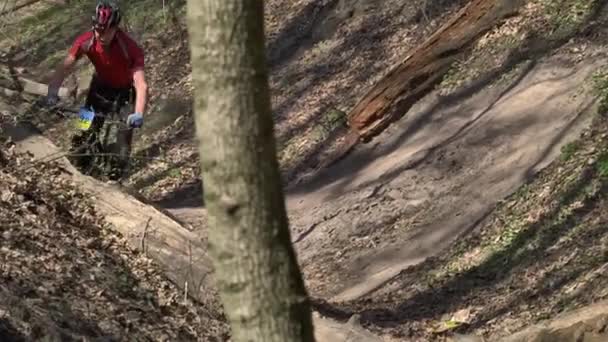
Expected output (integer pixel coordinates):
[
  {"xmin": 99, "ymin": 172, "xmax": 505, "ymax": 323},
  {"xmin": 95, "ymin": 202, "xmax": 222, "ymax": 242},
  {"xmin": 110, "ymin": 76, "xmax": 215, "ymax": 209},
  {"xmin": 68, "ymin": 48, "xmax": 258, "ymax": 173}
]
[{"xmin": 348, "ymin": 0, "xmax": 522, "ymax": 143}]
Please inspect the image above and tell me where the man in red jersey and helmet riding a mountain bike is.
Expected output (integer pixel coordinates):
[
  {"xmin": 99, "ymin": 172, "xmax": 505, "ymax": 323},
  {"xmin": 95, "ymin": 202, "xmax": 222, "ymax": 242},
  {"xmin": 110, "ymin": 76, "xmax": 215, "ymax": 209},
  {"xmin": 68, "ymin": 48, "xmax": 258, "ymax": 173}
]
[{"xmin": 47, "ymin": 0, "xmax": 147, "ymax": 180}]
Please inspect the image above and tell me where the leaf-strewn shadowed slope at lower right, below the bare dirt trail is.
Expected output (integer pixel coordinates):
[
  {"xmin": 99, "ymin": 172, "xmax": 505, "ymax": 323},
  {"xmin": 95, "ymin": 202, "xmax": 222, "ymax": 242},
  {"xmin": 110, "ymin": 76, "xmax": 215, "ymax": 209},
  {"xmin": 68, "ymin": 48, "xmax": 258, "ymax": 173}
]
[{"xmin": 319, "ymin": 111, "xmax": 608, "ymax": 341}]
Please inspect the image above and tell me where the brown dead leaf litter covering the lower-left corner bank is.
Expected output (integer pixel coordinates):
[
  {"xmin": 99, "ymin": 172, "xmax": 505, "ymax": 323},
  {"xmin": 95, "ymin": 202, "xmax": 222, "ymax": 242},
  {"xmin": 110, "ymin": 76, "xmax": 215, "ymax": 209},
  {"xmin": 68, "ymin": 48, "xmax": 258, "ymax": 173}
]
[{"xmin": 0, "ymin": 135, "xmax": 229, "ymax": 341}]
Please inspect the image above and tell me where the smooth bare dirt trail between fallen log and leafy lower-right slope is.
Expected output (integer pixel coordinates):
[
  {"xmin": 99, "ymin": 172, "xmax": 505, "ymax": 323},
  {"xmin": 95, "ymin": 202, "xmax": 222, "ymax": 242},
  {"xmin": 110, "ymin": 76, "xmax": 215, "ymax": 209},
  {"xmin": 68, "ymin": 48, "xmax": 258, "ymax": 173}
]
[{"xmin": 288, "ymin": 52, "xmax": 601, "ymax": 301}]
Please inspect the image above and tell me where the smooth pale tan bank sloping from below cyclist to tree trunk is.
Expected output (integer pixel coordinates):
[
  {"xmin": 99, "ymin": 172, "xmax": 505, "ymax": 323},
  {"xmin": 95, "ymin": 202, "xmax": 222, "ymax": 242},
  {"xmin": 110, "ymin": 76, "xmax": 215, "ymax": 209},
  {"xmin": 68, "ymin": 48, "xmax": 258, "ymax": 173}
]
[{"xmin": 2, "ymin": 122, "xmax": 213, "ymax": 301}]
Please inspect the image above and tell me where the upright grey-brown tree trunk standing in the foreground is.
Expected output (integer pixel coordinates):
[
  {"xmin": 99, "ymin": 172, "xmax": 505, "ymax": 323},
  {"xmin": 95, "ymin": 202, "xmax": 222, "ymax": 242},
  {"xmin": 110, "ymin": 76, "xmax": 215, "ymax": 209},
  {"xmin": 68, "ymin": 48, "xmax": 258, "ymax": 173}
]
[{"xmin": 188, "ymin": 0, "xmax": 314, "ymax": 342}]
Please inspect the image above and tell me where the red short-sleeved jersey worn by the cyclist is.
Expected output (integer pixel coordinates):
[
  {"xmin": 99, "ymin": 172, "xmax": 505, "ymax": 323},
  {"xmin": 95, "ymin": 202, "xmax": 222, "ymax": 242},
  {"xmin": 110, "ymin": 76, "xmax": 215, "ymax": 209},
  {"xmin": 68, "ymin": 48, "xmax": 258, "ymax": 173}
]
[{"xmin": 69, "ymin": 29, "xmax": 144, "ymax": 88}]
